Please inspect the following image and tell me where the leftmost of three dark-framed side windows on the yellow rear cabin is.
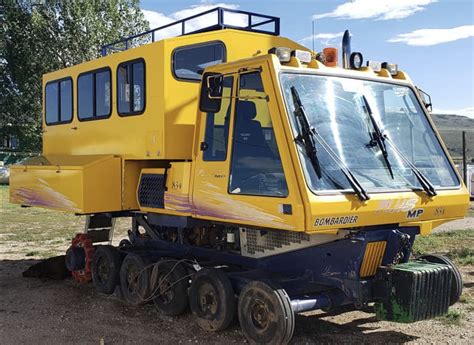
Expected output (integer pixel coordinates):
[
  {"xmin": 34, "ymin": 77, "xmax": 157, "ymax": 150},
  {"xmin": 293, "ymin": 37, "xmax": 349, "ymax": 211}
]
[{"xmin": 45, "ymin": 78, "xmax": 72, "ymax": 125}]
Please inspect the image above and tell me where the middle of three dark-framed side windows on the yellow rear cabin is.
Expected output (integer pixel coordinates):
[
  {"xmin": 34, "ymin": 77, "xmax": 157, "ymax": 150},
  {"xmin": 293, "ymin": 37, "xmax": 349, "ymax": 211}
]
[{"xmin": 77, "ymin": 68, "xmax": 112, "ymax": 120}]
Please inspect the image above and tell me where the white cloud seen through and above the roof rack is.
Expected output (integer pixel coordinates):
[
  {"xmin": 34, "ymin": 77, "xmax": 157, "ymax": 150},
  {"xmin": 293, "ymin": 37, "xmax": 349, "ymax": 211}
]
[{"xmin": 142, "ymin": 2, "xmax": 243, "ymax": 40}]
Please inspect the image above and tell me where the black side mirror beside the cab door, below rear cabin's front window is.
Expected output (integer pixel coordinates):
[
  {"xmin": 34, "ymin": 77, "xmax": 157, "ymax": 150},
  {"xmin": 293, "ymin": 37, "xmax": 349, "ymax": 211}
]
[{"xmin": 199, "ymin": 72, "xmax": 224, "ymax": 113}]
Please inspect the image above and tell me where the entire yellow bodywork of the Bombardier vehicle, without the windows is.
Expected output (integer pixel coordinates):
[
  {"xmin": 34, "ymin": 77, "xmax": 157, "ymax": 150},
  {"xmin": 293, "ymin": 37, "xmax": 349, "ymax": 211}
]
[{"xmin": 11, "ymin": 29, "xmax": 469, "ymax": 234}]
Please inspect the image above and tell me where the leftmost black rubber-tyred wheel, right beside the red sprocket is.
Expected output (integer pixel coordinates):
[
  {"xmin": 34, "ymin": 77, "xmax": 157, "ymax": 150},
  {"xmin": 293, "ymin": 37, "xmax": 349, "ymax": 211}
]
[{"xmin": 91, "ymin": 245, "xmax": 122, "ymax": 294}]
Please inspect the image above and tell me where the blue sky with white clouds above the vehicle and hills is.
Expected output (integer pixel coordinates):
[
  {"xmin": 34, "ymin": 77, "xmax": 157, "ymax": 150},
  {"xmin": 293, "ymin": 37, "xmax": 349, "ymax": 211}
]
[{"xmin": 141, "ymin": 0, "xmax": 474, "ymax": 118}]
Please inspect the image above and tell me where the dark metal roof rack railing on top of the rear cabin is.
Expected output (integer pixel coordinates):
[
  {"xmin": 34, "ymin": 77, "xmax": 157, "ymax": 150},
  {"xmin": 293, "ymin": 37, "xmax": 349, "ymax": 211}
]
[{"xmin": 101, "ymin": 7, "xmax": 280, "ymax": 56}]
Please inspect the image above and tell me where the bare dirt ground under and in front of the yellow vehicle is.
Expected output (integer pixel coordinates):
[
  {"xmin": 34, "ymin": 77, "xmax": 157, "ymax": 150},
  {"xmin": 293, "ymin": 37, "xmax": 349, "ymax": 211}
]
[{"xmin": 0, "ymin": 260, "xmax": 474, "ymax": 344}]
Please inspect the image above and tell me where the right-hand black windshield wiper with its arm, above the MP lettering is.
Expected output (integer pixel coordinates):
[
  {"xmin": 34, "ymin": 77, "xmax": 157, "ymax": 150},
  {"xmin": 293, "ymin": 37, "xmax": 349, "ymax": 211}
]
[{"xmin": 362, "ymin": 95, "xmax": 437, "ymax": 196}]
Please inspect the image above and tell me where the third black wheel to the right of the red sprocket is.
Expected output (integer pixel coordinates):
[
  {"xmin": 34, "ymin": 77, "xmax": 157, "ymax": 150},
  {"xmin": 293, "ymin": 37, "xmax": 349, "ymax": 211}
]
[{"xmin": 151, "ymin": 259, "xmax": 189, "ymax": 316}]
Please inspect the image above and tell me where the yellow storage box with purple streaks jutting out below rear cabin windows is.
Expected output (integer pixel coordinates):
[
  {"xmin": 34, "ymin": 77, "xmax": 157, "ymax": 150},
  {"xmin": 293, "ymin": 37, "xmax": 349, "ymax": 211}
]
[{"xmin": 10, "ymin": 155, "xmax": 121, "ymax": 213}]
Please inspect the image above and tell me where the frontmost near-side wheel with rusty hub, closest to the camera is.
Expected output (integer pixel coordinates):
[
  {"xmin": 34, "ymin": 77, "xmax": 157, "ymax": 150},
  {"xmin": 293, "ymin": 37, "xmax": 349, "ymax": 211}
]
[{"xmin": 238, "ymin": 281, "xmax": 295, "ymax": 344}]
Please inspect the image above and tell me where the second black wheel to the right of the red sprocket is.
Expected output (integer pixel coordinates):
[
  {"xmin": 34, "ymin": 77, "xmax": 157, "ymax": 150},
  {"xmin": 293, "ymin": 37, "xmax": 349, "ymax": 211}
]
[{"xmin": 120, "ymin": 253, "xmax": 150, "ymax": 305}]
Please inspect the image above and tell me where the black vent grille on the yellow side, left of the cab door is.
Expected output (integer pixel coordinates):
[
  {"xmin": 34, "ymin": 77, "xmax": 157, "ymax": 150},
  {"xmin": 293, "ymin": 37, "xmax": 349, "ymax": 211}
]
[{"xmin": 138, "ymin": 174, "xmax": 165, "ymax": 208}]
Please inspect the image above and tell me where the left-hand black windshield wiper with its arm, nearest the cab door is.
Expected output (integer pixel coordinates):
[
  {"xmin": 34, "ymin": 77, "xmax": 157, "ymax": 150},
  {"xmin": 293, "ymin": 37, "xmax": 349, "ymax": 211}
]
[{"xmin": 290, "ymin": 86, "xmax": 370, "ymax": 201}]
